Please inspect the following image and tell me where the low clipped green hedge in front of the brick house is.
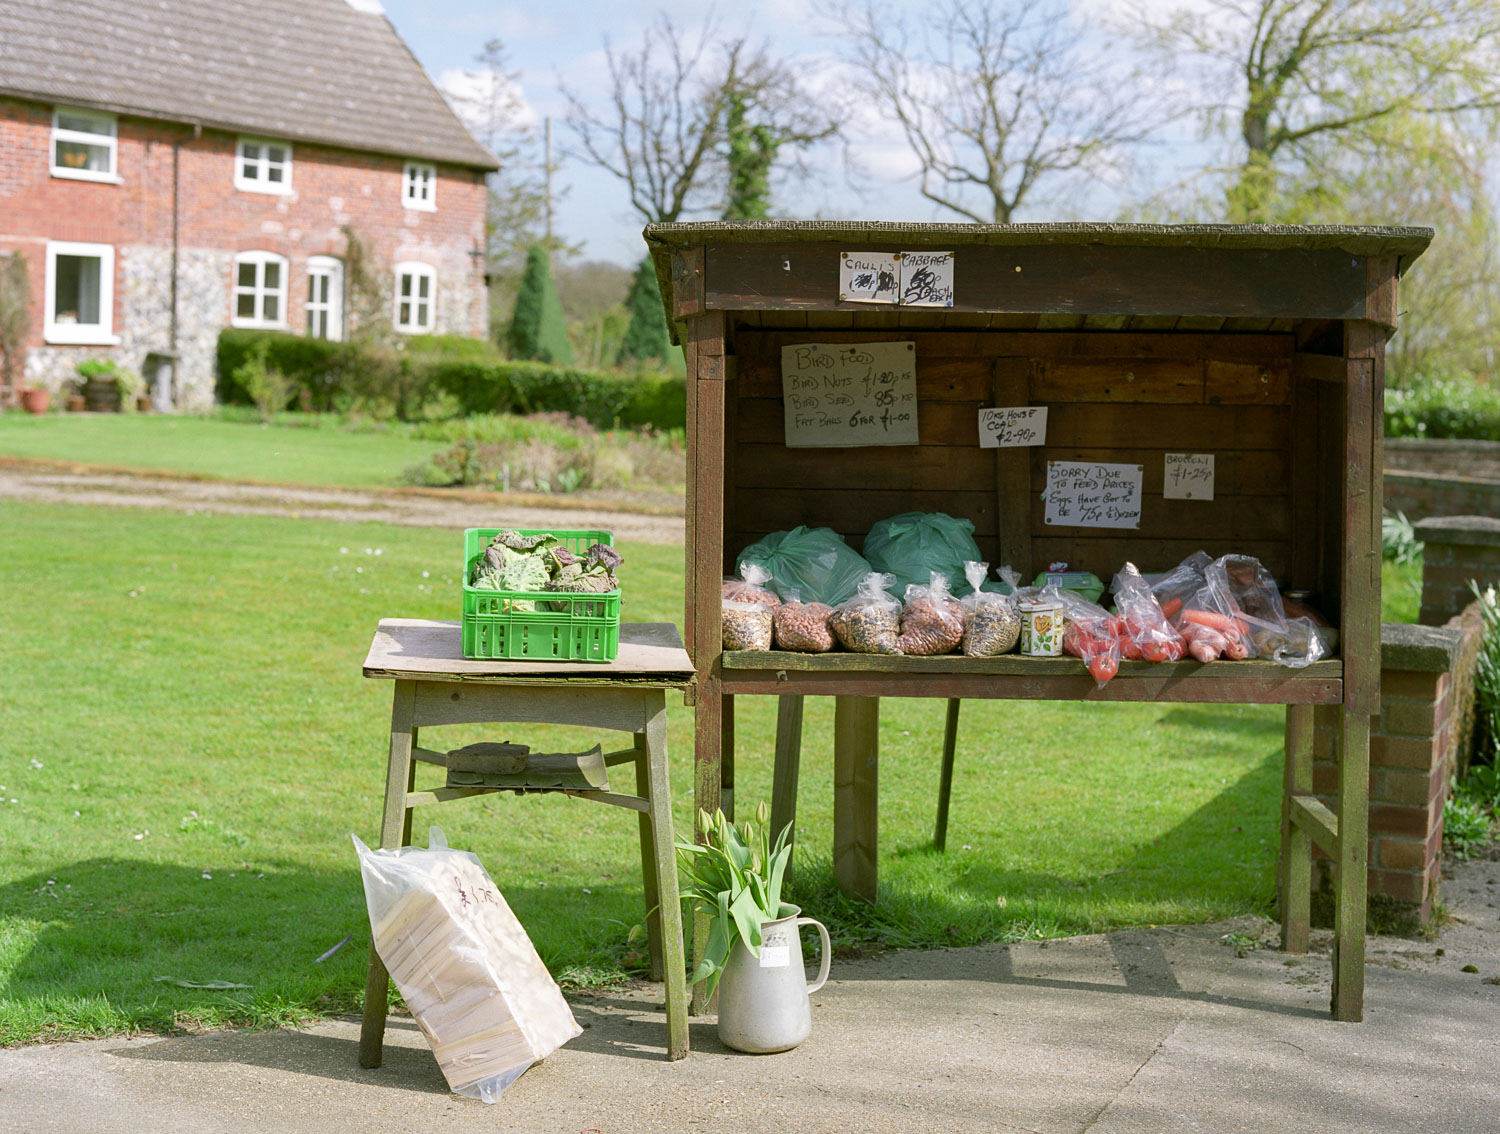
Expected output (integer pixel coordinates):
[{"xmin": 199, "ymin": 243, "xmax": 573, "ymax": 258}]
[{"xmin": 218, "ymin": 329, "xmax": 687, "ymax": 429}]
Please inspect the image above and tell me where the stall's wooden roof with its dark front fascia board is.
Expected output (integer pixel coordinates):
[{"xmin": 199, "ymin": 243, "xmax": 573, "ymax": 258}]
[{"xmin": 644, "ymin": 221, "xmax": 1433, "ymax": 340}]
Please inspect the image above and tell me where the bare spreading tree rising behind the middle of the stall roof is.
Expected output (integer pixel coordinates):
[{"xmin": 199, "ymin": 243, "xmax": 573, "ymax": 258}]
[{"xmin": 824, "ymin": 0, "xmax": 1154, "ymax": 224}]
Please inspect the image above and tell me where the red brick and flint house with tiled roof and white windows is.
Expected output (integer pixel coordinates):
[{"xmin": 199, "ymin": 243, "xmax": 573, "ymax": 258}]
[{"xmin": 0, "ymin": 0, "xmax": 497, "ymax": 408}]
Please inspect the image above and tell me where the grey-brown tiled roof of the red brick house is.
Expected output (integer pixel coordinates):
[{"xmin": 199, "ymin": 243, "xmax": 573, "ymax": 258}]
[{"xmin": 0, "ymin": 0, "xmax": 497, "ymax": 170}]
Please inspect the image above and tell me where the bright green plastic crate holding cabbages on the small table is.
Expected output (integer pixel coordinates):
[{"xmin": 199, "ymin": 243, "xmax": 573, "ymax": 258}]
[{"xmin": 462, "ymin": 528, "xmax": 620, "ymax": 662}]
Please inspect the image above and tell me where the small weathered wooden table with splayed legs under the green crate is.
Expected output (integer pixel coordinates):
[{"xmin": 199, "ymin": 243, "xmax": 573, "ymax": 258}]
[{"xmin": 360, "ymin": 618, "xmax": 693, "ymax": 1067}]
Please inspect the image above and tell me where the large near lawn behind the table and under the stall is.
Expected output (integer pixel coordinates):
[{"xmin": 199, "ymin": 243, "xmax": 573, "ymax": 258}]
[{"xmin": 0, "ymin": 504, "xmax": 1281, "ymax": 1044}]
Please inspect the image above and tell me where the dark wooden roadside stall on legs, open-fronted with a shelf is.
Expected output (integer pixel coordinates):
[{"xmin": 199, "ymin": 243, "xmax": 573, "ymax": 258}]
[{"xmin": 645, "ymin": 222, "xmax": 1433, "ymax": 1020}]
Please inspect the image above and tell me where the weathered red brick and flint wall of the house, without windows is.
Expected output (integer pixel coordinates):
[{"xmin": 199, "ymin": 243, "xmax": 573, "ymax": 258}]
[{"xmin": 0, "ymin": 99, "xmax": 488, "ymax": 404}]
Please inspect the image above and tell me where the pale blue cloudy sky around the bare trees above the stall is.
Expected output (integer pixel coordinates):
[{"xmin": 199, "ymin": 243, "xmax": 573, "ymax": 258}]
[{"xmin": 383, "ymin": 0, "xmax": 1206, "ymax": 264}]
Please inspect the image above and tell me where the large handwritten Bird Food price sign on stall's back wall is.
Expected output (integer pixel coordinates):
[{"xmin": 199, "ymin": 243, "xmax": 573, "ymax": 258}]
[{"xmin": 782, "ymin": 342, "xmax": 917, "ymax": 449}]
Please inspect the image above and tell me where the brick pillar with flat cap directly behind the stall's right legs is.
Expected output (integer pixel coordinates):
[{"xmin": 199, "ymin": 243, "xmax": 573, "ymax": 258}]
[{"xmin": 1313, "ymin": 623, "xmax": 1466, "ymax": 921}]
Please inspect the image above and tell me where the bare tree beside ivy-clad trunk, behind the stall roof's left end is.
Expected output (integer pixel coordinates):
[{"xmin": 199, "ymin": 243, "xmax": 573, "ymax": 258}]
[{"xmin": 563, "ymin": 15, "xmax": 842, "ymax": 222}]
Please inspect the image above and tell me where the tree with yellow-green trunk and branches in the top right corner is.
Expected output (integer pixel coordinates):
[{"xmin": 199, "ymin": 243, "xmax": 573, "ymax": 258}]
[{"xmin": 1131, "ymin": 0, "xmax": 1500, "ymax": 221}]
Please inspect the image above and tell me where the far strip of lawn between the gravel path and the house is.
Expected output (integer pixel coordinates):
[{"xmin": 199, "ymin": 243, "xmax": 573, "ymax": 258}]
[{"xmin": 0, "ymin": 414, "xmax": 447, "ymax": 488}]
